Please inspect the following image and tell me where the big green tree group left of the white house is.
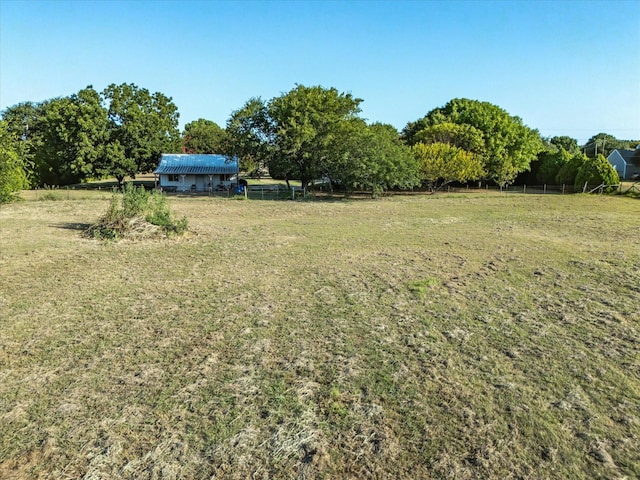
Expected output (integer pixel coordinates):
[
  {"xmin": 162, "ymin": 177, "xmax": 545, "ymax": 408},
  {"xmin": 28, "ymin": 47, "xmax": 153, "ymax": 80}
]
[{"xmin": 3, "ymin": 84, "xmax": 180, "ymax": 185}]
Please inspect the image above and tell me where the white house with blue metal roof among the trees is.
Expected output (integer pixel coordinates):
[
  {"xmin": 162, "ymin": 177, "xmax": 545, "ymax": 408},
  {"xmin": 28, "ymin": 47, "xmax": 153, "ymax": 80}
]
[{"xmin": 153, "ymin": 153, "xmax": 238, "ymax": 192}]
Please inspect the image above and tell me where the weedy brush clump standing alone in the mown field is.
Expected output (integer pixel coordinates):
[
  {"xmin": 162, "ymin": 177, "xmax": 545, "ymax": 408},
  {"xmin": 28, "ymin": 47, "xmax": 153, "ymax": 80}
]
[{"xmin": 87, "ymin": 183, "xmax": 187, "ymax": 240}]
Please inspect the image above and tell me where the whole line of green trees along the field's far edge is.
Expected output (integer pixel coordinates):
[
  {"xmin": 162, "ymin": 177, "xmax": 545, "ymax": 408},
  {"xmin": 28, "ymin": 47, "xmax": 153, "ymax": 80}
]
[{"xmin": 0, "ymin": 84, "xmax": 637, "ymax": 200}]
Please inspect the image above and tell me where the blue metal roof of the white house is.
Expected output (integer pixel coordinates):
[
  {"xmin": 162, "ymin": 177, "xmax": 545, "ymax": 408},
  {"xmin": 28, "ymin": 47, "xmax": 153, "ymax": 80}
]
[{"xmin": 153, "ymin": 153, "xmax": 238, "ymax": 175}]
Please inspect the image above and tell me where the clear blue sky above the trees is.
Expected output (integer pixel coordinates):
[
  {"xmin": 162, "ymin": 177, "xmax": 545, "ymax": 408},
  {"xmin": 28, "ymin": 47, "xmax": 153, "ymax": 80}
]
[{"xmin": 0, "ymin": 0, "xmax": 640, "ymax": 143}]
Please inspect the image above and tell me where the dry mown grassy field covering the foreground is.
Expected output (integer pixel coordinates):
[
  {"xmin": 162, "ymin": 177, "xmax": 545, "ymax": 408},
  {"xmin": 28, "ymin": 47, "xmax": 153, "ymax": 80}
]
[{"xmin": 0, "ymin": 192, "xmax": 640, "ymax": 479}]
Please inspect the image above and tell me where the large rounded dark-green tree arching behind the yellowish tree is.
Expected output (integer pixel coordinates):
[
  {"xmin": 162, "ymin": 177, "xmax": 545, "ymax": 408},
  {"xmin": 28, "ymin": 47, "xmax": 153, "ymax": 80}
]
[{"xmin": 403, "ymin": 98, "xmax": 542, "ymax": 185}]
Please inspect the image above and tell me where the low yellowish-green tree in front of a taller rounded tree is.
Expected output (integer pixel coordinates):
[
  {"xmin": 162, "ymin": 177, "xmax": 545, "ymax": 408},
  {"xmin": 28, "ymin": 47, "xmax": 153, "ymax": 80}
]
[{"xmin": 411, "ymin": 142, "xmax": 485, "ymax": 188}]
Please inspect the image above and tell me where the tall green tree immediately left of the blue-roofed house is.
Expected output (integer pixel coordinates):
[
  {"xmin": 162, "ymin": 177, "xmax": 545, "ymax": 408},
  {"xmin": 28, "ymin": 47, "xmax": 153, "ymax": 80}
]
[{"xmin": 102, "ymin": 83, "xmax": 180, "ymax": 184}]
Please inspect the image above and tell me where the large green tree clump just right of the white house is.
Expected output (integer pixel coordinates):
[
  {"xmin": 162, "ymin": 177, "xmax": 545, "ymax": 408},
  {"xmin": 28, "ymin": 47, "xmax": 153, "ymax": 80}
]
[{"xmin": 227, "ymin": 85, "xmax": 418, "ymax": 196}]
